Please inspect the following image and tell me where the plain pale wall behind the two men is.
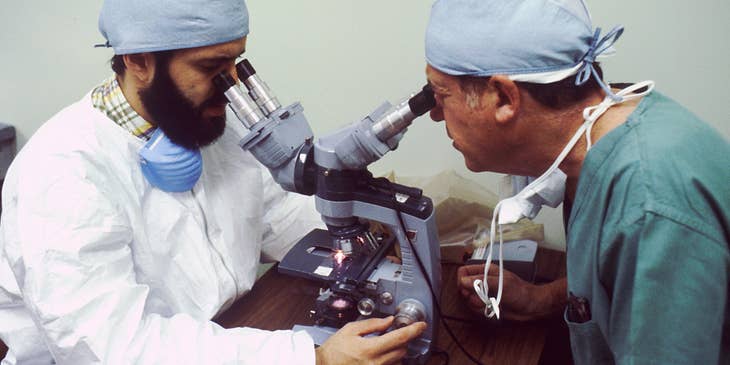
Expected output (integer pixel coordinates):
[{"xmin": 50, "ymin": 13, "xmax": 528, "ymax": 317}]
[{"xmin": 0, "ymin": 0, "xmax": 730, "ymax": 247}]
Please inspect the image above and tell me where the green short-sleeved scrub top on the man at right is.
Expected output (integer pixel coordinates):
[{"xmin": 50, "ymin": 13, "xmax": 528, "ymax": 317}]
[{"xmin": 566, "ymin": 92, "xmax": 730, "ymax": 364}]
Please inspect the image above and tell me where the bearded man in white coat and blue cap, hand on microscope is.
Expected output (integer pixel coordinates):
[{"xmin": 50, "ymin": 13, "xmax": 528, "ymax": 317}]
[{"xmin": 0, "ymin": 0, "xmax": 425, "ymax": 365}]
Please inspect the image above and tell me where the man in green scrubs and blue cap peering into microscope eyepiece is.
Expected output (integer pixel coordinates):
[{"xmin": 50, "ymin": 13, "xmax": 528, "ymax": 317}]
[{"xmin": 426, "ymin": 0, "xmax": 730, "ymax": 364}]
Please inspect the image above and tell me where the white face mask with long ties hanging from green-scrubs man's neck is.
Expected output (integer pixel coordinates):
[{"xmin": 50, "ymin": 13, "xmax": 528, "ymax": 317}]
[{"xmin": 474, "ymin": 81, "xmax": 654, "ymax": 319}]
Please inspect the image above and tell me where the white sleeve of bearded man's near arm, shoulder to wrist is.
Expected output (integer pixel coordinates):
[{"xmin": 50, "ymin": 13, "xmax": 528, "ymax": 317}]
[{"xmin": 3, "ymin": 155, "xmax": 315, "ymax": 364}]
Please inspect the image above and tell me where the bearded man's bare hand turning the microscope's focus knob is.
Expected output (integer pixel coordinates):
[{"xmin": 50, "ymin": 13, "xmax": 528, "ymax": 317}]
[{"xmin": 315, "ymin": 316, "xmax": 426, "ymax": 365}]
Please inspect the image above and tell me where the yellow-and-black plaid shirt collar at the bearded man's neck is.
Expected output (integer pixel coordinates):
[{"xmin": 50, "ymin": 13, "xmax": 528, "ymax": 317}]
[{"xmin": 91, "ymin": 76, "xmax": 155, "ymax": 141}]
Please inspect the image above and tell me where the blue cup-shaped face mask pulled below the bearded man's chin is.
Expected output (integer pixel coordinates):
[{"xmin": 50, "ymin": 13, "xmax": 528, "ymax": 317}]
[{"xmin": 139, "ymin": 128, "xmax": 203, "ymax": 193}]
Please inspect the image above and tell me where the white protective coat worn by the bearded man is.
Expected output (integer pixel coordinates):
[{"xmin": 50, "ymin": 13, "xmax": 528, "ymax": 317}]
[{"xmin": 0, "ymin": 95, "xmax": 321, "ymax": 365}]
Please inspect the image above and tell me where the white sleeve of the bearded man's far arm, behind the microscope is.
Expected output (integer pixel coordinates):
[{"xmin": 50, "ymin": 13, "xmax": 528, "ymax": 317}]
[{"xmin": 261, "ymin": 168, "xmax": 324, "ymax": 262}]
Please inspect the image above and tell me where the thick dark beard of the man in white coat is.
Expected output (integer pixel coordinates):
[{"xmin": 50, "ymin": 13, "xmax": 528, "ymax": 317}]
[{"xmin": 139, "ymin": 62, "xmax": 228, "ymax": 150}]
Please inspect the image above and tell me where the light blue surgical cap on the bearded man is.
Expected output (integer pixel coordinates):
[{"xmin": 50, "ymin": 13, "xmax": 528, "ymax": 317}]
[{"xmin": 99, "ymin": 0, "xmax": 248, "ymax": 55}]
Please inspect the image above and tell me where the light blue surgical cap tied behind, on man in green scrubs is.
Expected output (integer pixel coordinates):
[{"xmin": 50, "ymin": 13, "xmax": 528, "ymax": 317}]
[{"xmin": 426, "ymin": 0, "xmax": 623, "ymax": 97}]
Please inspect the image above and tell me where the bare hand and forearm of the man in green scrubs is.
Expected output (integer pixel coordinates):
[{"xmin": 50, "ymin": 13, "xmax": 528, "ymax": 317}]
[{"xmin": 457, "ymin": 264, "xmax": 567, "ymax": 321}]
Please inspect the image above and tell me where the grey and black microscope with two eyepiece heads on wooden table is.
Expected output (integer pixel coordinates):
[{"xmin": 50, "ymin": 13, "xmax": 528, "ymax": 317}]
[{"xmin": 214, "ymin": 60, "xmax": 441, "ymax": 364}]
